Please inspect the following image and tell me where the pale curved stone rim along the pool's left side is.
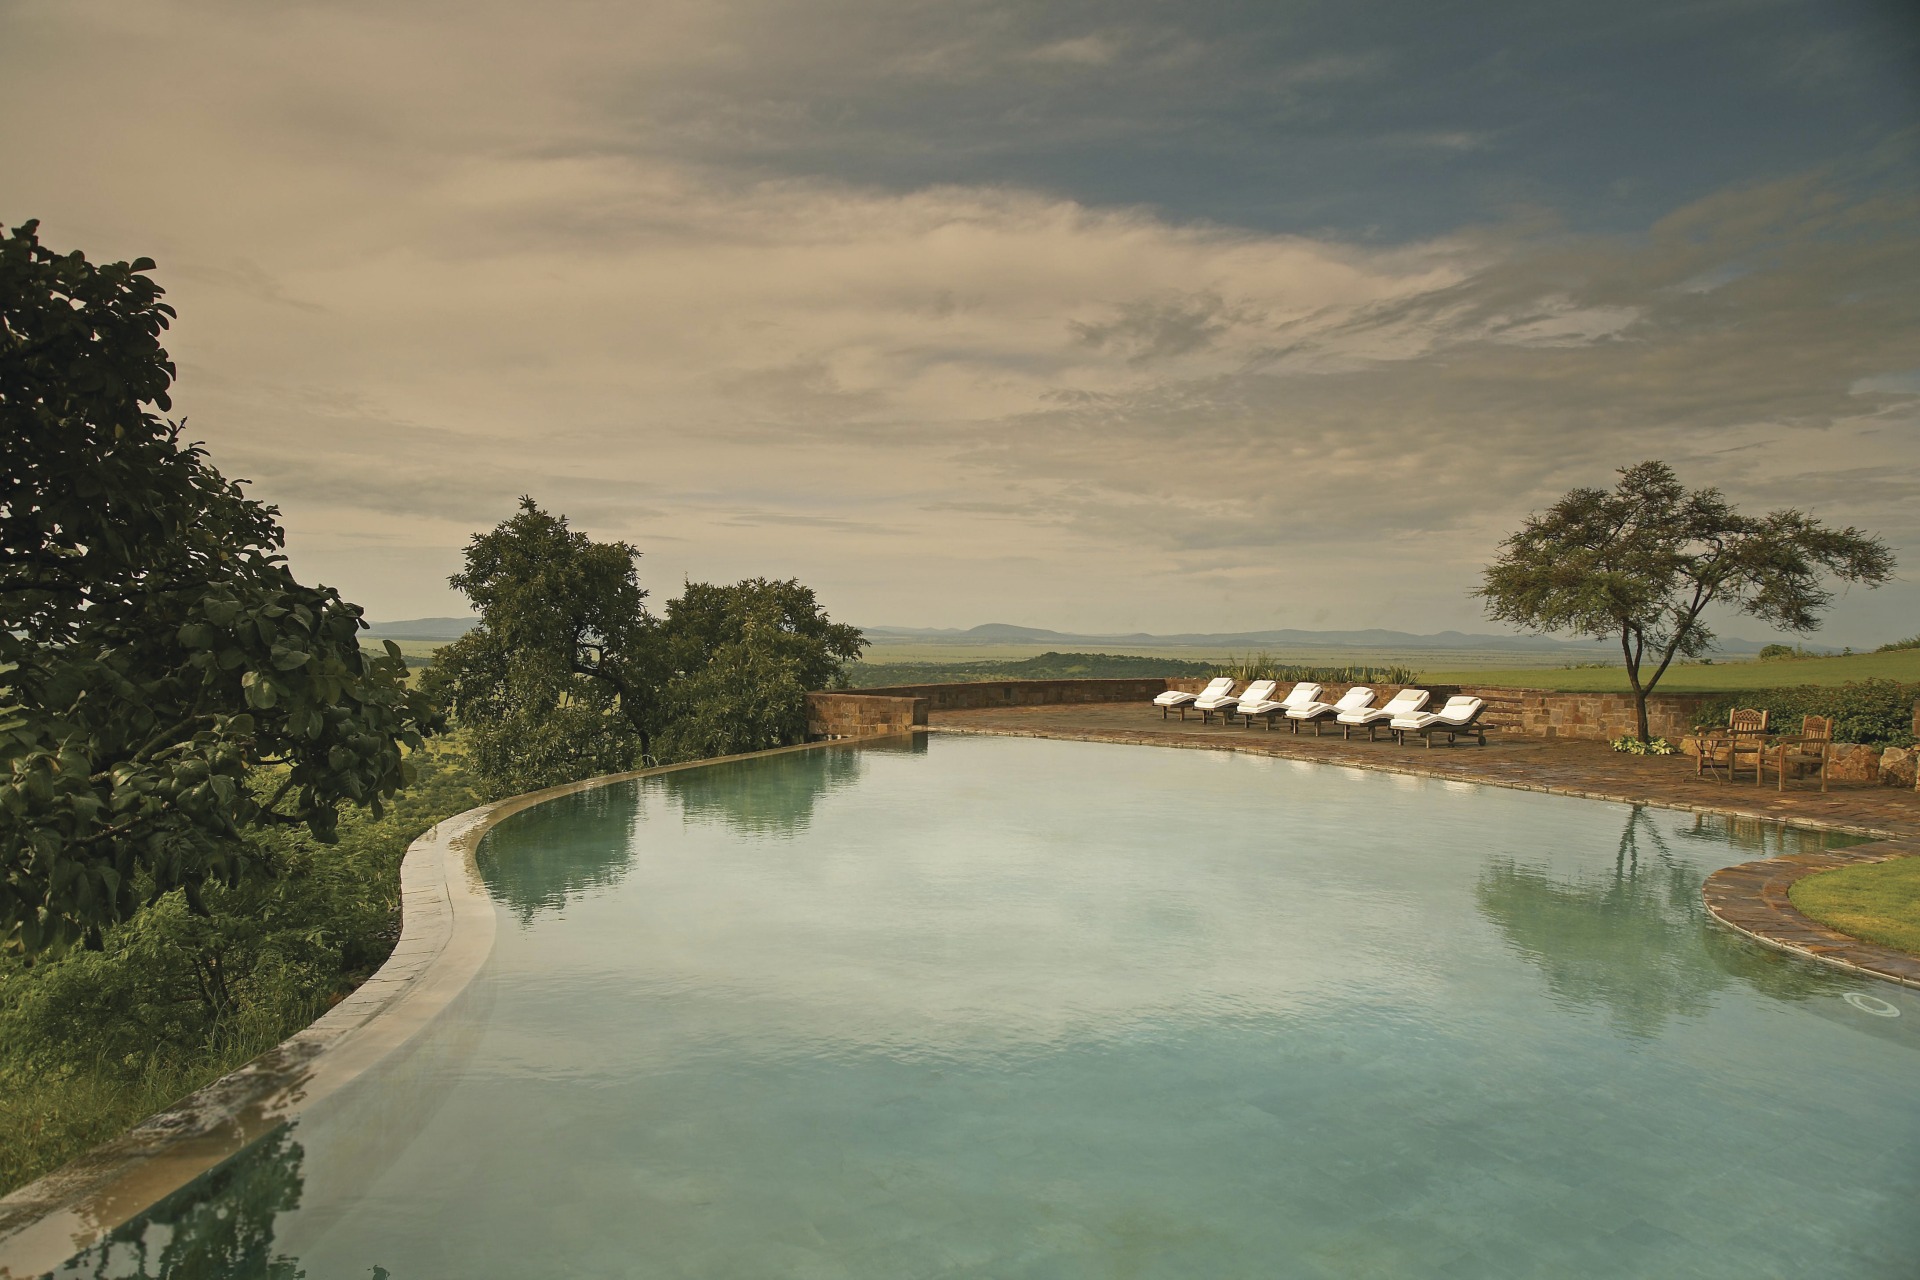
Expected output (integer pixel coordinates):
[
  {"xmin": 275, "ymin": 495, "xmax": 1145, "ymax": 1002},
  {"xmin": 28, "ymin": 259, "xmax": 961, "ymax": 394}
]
[{"xmin": 0, "ymin": 739, "xmax": 866, "ymax": 1280}]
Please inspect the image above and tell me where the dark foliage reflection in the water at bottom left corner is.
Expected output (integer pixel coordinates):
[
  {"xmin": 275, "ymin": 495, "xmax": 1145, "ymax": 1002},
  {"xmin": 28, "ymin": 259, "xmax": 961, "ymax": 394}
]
[{"xmin": 52, "ymin": 1126, "xmax": 330, "ymax": 1280}]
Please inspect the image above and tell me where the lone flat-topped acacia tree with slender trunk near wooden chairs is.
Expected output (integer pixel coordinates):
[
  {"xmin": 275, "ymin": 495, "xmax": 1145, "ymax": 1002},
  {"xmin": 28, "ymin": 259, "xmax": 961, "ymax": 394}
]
[{"xmin": 1475, "ymin": 461, "xmax": 1893, "ymax": 741}]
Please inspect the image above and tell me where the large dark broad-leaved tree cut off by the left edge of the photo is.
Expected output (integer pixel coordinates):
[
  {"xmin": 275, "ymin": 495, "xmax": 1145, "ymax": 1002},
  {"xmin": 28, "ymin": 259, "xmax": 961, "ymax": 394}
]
[{"xmin": 0, "ymin": 223, "xmax": 436, "ymax": 956}]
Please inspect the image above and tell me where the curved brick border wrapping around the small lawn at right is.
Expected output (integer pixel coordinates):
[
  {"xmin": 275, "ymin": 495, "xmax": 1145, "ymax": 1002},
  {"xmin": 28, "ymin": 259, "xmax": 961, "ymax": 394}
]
[{"xmin": 1699, "ymin": 841, "xmax": 1920, "ymax": 988}]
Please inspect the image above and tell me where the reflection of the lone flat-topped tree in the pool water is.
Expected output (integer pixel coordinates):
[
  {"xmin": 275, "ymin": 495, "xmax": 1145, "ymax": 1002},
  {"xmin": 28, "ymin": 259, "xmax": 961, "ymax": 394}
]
[{"xmin": 1475, "ymin": 806, "xmax": 1845, "ymax": 1038}]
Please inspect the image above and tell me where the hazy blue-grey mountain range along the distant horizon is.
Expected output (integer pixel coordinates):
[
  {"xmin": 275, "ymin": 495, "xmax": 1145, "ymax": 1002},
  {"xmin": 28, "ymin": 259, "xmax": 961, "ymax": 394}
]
[{"xmin": 371, "ymin": 618, "xmax": 1837, "ymax": 652}]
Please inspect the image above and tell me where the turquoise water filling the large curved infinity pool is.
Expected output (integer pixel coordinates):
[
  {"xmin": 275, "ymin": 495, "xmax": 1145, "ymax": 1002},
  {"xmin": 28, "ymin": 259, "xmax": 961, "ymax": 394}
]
[{"xmin": 45, "ymin": 739, "xmax": 1920, "ymax": 1280}]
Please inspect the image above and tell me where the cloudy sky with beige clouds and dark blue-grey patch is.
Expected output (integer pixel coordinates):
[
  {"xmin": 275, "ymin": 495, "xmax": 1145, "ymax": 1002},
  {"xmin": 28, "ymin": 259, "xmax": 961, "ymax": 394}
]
[{"xmin": 11, "ymin": 0, "xmax": 1920, "ymax": 645}]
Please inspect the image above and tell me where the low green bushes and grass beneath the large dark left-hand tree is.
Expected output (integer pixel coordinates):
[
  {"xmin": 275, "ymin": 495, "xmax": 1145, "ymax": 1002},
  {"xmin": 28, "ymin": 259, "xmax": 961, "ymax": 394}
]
[{"xmin": 0, "ymin": 743, "xmax": 478, "ymax": 1190}]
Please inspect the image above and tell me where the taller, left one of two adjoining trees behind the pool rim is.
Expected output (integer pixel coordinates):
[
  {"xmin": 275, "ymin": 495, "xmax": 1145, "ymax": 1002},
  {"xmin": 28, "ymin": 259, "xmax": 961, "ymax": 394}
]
[{"xmin": 426, "ymin": 497, "xmax": 660, "ymax": 794}]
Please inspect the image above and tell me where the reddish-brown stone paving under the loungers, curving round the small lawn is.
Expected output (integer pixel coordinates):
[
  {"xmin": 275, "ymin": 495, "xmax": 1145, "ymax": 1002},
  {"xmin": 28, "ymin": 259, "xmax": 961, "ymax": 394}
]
[{"xmin": 927, "ymin": 702, "xmax": 1920, "ymax": 986}]
